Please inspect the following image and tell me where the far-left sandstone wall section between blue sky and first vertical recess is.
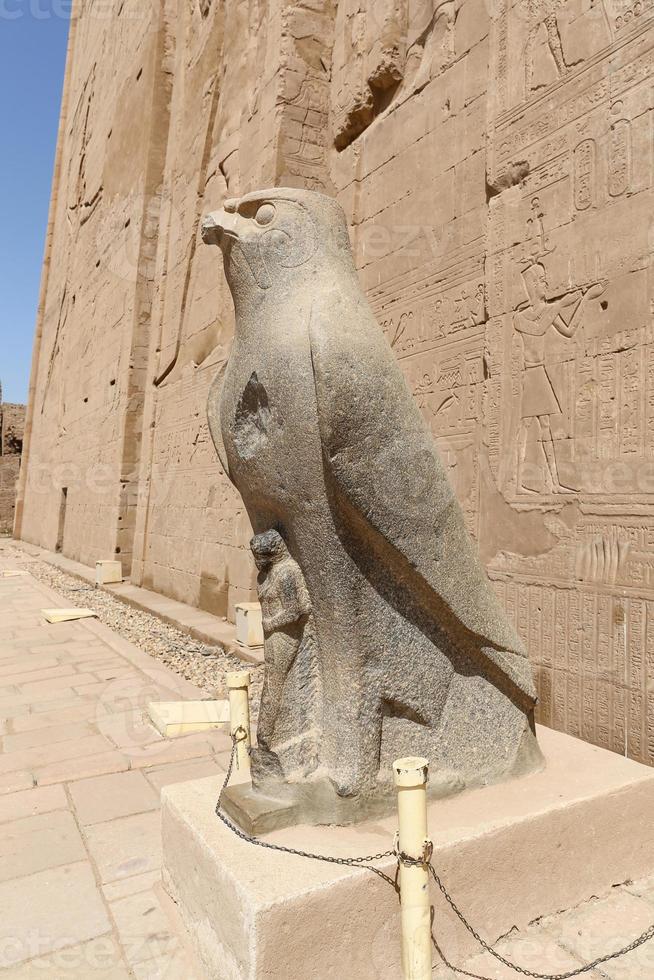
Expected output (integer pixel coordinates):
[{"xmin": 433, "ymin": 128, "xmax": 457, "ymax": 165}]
[{"xmin": 18, "ymin": 0, "xmax": 174, "ymax": 569}]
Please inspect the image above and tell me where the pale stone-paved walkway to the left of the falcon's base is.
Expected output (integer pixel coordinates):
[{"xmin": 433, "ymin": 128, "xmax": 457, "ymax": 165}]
[{"xmin": 0, "ymin": 543, "xmax": 229, "ymax": 980}]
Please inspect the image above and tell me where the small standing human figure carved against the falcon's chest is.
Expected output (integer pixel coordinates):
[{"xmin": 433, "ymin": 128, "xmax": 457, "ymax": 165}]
[{"xmin": 250, "ymin": 530, "xmax": 317, "ymax": 776}]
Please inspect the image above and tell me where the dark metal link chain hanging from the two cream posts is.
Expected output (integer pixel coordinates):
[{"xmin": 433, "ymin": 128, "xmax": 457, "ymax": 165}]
[{"xmin": 216, "ymin": 728, "xmax": 654, "ymax": 980}]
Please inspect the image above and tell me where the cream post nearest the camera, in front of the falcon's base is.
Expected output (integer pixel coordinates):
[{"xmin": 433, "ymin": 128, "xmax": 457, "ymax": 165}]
[{"xmin": 393, "ymin": 758, "xmax": 432, "ymax": 980}]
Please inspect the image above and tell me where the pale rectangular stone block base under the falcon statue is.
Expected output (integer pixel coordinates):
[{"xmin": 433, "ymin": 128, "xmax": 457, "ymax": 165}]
[{"xmin": 163, "ymin": 729, "xmax": 654, "ymax": 980}]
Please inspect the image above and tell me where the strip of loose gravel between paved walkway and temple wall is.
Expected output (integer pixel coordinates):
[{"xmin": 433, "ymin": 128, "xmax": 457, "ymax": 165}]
[{"xmin": 3, "ymin": 545, "xmax": 263, "ymax": 718}]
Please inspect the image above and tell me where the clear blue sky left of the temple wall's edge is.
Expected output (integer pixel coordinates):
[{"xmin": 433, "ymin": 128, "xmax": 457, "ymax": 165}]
[{"xmin": 0, "ymin": 0, "xmax": 70, "ymax": 402}]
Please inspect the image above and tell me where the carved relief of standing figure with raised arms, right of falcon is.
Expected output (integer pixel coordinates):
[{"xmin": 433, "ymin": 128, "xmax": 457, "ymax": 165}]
[{"xmin": 514, "ymin": 262, "xmax": 604, "ymax": 493}]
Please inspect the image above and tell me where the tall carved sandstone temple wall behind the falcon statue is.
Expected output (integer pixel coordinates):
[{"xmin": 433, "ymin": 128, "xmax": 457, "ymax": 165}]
[{"xmin": 18, "ymin": 0, "xmax": 654, "ymax": 764}]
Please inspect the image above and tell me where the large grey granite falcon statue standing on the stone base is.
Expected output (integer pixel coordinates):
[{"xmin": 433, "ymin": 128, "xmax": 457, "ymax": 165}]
[{"xmin": 202, "ymin": 188, "xmax": 542, "ymax": 819}]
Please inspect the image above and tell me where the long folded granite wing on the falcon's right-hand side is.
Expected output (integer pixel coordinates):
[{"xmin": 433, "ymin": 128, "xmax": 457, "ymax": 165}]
[{"xmin": 310, "ymin": 294, "xmax": 535, "ymax": 699}]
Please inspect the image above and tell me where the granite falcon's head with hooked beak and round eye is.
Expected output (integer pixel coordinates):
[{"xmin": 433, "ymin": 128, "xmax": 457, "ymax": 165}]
[{"xmin": 202, "ymin": 187, "xmax": 349, "ymax": 301}]
